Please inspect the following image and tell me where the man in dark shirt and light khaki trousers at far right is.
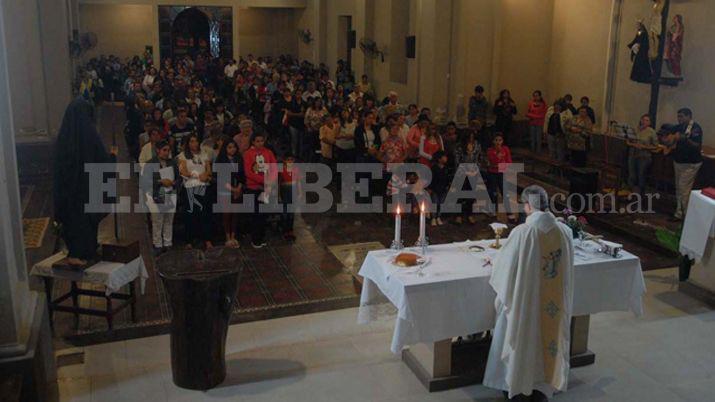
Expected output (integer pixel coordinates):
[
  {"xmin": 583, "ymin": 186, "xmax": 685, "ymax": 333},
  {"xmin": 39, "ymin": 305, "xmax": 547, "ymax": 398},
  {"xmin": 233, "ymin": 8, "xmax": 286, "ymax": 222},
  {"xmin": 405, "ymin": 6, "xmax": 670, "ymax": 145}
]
[{"xmin": 666, "ymin": 108, "xmax": 703, "ymax": 220}]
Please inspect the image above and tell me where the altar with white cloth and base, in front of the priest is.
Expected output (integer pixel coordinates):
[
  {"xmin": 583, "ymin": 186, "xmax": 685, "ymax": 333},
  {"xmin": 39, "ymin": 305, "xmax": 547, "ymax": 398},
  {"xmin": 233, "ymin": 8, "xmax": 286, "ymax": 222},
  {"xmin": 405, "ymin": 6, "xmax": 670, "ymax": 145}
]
[{"xmin": 358, "ymin": 240, "xmax": 646, "ymax": 392}]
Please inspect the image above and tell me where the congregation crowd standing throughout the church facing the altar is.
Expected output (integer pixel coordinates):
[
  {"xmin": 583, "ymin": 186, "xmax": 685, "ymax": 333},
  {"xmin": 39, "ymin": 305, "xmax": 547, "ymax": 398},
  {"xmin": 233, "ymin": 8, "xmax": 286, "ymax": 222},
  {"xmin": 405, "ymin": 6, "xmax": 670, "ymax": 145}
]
[{"xmin": 77, "ymin": 54, "xmax": 702, "ymax": 253}]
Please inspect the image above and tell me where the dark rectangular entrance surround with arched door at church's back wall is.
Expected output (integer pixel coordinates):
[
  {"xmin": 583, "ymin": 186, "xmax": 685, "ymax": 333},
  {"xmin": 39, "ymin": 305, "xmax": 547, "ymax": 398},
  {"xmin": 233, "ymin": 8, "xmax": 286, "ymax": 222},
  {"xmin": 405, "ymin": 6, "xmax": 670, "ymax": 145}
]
[{"xmin": 159, "ymin": 6, "xmax": 233, "ymax": 59}]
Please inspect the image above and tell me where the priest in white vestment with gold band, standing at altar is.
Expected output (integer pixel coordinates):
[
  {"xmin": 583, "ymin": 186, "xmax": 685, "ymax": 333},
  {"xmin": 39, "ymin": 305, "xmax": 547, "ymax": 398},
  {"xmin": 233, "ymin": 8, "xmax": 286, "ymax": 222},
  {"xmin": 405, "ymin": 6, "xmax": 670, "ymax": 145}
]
[{"xmin": 483, "ymin": 186, "xmax": 574, "ymax": 400}]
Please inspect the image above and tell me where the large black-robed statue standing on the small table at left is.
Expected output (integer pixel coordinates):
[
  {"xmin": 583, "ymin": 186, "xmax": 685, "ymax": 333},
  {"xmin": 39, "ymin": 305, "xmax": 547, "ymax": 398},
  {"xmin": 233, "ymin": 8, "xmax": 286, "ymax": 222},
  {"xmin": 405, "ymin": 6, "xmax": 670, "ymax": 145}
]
[{"xmin": 53, "ymin": 97, "xmax": 115, "ymax": 265}]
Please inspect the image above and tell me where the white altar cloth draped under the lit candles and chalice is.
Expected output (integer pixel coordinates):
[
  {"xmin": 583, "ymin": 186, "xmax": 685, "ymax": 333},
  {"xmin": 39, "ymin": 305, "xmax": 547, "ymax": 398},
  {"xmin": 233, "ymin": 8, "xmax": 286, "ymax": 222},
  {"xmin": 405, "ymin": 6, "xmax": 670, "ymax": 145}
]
[{"xmin": 358, "ymin": 240, "xmax": 646, "ymax": 354}]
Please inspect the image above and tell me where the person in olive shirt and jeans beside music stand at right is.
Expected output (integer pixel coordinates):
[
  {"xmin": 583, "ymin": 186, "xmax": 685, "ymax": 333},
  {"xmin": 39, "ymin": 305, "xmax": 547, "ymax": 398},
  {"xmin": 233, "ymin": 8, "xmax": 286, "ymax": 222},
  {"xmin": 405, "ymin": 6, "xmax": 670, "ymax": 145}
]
[{"xmin": 628, "ymin": 114, "xmax": 659, "ymax": 197}]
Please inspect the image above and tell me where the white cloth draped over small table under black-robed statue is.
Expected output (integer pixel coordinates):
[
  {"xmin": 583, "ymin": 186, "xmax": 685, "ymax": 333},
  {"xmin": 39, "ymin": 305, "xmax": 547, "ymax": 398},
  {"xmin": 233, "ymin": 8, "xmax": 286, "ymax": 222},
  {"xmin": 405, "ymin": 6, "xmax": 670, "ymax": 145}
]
[{"xmin": 30, "ymin": 252, "xmax": 149, "ymax": 296}]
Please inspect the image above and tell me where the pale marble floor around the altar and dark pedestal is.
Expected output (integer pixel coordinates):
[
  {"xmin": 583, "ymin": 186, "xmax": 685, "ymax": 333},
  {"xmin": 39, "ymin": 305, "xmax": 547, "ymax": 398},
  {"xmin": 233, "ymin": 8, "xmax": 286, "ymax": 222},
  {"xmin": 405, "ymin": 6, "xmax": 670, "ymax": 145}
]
[{"xmin": 59, "ymin": 269, "xmax": 715, "ymax": 402}]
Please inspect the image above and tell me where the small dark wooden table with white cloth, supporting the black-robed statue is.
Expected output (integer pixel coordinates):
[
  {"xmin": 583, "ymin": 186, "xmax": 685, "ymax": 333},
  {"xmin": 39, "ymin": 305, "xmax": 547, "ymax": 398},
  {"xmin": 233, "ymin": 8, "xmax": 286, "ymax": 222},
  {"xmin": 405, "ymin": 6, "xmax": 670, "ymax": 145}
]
[{"xmin": 30, "ymin": 253, "xmax": 149, "ymax": 331}]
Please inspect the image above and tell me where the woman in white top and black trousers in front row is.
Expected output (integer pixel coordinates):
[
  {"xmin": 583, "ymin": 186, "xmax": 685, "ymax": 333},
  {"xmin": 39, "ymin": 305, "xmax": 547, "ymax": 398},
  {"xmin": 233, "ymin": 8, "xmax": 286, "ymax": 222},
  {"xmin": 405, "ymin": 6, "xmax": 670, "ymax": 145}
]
[{"xmin": 177, "ymin": 134, "xmax": 213, "ymax": 249}]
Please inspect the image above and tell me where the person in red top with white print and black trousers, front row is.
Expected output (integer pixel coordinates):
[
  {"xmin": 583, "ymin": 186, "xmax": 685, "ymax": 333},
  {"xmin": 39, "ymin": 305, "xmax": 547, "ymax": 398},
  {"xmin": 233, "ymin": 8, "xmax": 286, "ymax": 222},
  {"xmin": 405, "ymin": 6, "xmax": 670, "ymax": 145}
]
[{"xmin": 243, "ymin": 133, "xmax": 277, "ymax": 249}]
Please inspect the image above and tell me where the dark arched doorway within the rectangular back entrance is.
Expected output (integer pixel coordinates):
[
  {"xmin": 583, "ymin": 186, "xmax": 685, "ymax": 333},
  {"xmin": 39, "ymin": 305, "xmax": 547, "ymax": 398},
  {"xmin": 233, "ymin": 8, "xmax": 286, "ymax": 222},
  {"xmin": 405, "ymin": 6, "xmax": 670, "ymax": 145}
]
[{"xmin": 171, "ymin": 7, "xmax": 211, "ymax": 58}]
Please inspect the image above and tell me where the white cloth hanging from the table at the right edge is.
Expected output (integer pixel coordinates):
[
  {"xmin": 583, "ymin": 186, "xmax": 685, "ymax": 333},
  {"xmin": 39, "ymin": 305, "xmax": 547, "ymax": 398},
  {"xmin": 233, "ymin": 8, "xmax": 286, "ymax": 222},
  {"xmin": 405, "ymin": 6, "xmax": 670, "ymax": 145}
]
[{"xmin": 679, "ymin": 191, "xmax": 715, "ymax": 260}]
